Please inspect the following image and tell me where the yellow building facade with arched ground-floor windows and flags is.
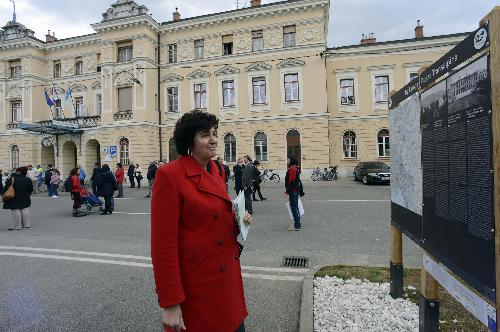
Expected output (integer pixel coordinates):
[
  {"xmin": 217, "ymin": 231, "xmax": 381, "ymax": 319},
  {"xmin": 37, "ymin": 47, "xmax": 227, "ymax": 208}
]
[{"xmin": 0, "ymin": 0, "xmax": 465, "ymax": 177}]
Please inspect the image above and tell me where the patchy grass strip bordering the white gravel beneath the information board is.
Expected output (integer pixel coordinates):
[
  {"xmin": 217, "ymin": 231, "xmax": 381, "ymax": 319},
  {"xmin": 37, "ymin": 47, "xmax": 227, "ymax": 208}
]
[{"xmin": 314, "ymin": 265, "xmax": 488, "ymax": 332}]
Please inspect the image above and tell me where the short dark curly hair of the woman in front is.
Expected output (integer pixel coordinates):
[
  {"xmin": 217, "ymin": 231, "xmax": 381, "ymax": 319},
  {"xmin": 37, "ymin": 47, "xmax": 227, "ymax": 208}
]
[{"xmin": 174, "ymin": 111, "xmax": 219, "ymax": 156}]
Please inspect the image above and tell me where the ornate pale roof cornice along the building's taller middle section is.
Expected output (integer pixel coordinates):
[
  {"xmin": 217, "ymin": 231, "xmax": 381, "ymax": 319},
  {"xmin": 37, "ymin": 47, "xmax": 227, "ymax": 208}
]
[{"xmin": 161, "ymin": 0, "xmax": 329, "ymax": 33}]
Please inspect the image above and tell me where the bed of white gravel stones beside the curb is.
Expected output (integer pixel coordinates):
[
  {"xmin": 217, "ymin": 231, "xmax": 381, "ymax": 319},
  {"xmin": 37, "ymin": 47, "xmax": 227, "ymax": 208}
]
[{"xmin": 314, "ymin": 276, "xmax": 418, "ymax": 332}]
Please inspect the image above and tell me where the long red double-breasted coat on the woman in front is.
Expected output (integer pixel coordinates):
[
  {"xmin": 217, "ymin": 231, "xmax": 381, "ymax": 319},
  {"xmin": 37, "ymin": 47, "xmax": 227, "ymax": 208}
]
[{"xmin": 151, "ymin": 156, "xmax": 247, "ymax": 332}]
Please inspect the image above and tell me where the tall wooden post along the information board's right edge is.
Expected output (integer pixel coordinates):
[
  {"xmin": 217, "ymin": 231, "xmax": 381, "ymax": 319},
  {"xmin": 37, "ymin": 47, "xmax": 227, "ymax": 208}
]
[{"xmin": 479, "ymin": 6, "xmax": 500, "ymax": 332}]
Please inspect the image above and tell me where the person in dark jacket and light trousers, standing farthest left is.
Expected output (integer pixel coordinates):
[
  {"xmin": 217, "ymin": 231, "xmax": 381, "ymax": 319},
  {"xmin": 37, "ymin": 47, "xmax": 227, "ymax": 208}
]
[{"xmin": 2, "ymin": 167, "xmax": 33, "ymax": 231}]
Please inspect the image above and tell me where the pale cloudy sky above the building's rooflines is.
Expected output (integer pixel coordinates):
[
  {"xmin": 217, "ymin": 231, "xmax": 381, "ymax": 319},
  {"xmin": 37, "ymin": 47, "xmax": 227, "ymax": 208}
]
[{"xmin": 0, "ymin": 0, "xmax": 500, "ymax": 47}]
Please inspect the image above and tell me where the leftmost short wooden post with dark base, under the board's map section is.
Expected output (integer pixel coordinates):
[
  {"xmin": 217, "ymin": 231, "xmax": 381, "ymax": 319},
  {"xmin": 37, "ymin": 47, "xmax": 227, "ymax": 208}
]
[{"xmin": 390, "ymin": 225, "xmax": 404, "ymax": 299}]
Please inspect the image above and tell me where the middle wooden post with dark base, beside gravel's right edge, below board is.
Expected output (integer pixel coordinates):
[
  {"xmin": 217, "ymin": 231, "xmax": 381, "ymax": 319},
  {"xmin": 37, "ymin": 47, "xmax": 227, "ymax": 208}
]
[{"xmin": 418, "ymin": 253, "xmax": 439, "ymax": 332}]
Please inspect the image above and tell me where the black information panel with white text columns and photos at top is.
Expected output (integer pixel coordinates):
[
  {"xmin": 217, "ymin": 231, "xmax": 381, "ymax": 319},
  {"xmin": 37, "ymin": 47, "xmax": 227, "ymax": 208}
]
[{"xmin": 421, "ymin": 55, "xmax": 495, "ymax": 299}]
